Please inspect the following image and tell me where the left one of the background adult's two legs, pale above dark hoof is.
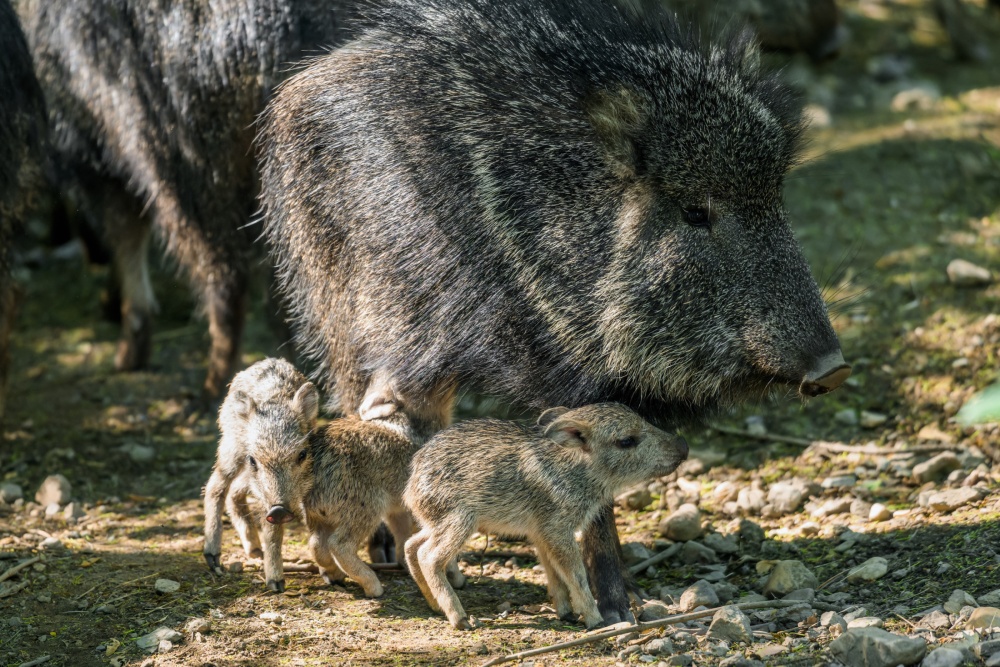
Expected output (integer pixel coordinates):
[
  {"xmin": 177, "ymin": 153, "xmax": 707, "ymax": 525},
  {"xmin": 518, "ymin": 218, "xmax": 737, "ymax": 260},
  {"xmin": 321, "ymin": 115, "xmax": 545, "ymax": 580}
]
[{"xmin": 109, "ymin": 215, "xmax": 158, "ymax": 371}]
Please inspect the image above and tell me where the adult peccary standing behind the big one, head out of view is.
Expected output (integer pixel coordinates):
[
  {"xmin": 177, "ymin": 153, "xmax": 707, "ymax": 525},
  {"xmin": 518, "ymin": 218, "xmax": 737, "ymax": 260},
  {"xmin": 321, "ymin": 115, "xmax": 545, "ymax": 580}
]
[{"xmin": 18, "ymin": 0, "xmax": 348, "ymax": 398}]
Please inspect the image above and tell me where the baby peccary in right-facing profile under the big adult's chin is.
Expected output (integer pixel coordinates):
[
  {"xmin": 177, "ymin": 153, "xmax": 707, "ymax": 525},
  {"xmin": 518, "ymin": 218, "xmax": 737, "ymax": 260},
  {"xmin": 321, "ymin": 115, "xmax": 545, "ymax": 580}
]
[{"xmin": 405, "ymin": 403, "xmax": 687, "ymax": 630}]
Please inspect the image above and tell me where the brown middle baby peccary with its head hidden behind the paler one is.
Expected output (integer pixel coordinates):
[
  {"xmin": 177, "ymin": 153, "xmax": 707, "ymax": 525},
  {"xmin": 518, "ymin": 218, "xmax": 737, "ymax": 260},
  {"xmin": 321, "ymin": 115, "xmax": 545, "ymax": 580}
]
[{"xmin": 305, "ymin": 411, "xmax": 419, "ymax": 597}]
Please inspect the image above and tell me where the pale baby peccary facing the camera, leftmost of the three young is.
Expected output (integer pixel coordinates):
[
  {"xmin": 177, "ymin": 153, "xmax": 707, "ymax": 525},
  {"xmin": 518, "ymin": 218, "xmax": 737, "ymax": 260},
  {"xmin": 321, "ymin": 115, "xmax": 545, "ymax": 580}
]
[{"xmin": 205, "ymin": 359, "xmax": 319, "ymax": 591}]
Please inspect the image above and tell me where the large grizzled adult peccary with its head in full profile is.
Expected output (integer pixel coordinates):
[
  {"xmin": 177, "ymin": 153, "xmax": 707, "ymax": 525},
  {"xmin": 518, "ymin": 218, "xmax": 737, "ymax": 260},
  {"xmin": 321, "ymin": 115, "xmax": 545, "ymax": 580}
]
[{"xmin": 261, "ymin": 0, "xmax": 850, "ymax": 621}]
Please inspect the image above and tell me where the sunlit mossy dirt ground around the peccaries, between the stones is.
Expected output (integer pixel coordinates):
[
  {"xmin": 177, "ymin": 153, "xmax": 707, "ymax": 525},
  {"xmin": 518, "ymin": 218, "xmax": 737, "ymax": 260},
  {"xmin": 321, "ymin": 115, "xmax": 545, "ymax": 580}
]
[{"xmin": 0, "ymin": 0, "xmax": 1000, "ymax": 667}]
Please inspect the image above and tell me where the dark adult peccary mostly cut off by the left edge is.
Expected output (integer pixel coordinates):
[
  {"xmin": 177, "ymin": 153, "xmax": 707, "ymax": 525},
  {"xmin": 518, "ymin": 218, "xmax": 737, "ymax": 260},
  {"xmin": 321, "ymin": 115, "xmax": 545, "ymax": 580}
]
[{"xmin": 0, "ymin": 0, "xmax": 45, "ymax": 420}]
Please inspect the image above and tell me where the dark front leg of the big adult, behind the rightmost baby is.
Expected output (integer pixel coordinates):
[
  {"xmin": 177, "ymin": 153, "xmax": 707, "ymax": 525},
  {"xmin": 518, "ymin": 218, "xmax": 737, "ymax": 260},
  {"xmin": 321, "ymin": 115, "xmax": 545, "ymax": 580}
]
[{"xmin": 583, "ymin": 504, "xmax": 635, "ymax": 625}]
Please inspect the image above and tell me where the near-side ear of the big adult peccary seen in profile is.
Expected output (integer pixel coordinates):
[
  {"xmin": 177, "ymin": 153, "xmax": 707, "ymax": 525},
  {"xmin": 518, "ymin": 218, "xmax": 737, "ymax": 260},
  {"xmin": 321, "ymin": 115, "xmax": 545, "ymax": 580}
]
[{"xmin": 583, "ymin": 86, "xmax": 648, "ymax": 178}]
